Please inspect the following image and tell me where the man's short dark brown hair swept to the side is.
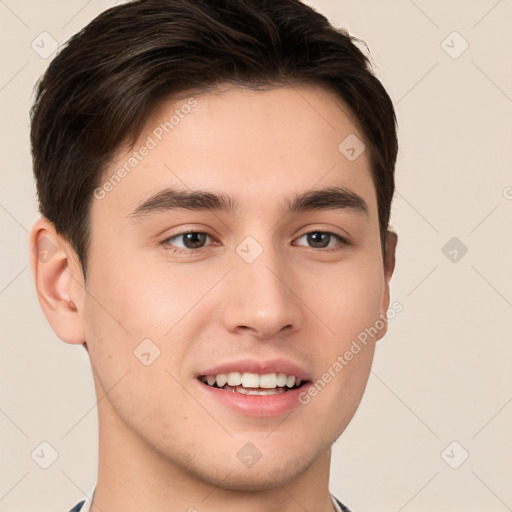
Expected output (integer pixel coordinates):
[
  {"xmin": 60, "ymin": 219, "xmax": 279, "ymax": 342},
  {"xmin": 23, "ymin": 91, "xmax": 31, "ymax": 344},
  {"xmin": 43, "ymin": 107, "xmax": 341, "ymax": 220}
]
[{"xmin": 31, "ymin": 0, "xmax": 398, "ymax": 277}]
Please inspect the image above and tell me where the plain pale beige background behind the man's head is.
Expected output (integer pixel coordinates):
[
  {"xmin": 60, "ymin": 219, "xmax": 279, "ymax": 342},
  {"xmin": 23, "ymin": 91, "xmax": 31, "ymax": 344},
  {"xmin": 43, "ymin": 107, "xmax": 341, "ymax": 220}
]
[{"xmin": 0, "ymin": 0, "xmax": 512, "ymax": 512}]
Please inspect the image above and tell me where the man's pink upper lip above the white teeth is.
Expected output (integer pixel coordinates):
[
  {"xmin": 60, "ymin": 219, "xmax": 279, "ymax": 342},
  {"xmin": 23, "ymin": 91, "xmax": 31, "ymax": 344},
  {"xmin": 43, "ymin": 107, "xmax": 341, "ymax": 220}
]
[{"xmin": 196, "ymin": 359, "xmax": 311, "ymax": 381}]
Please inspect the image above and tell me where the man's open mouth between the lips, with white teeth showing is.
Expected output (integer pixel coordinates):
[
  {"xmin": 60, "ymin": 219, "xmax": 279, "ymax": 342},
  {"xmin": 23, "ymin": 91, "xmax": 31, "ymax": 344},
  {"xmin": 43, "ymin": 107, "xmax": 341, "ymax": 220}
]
[{"xmin": 198, "ymin": 372, "xmax": 310, "ymax": 396}]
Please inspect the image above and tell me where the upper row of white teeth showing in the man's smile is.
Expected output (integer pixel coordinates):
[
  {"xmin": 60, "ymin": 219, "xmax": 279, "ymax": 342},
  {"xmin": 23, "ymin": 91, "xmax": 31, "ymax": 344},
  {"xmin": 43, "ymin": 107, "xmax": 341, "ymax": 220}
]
[{"xmin": 201, "ymin": 372, "xmax": 302, "ymax": 394}]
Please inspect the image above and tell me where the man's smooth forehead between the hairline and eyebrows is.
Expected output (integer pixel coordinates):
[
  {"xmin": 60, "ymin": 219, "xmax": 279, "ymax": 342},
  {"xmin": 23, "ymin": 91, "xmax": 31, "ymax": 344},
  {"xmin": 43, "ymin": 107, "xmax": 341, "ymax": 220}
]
[{"xmin": 95, "ymin": 85, "xmax": 375, "ymax": 222}]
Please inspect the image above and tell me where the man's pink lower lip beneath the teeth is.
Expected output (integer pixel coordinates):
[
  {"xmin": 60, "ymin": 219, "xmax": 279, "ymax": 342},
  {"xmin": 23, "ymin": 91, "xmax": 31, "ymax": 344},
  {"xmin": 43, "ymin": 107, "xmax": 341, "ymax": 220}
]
[{"xmin": 197, "ymin": 380, "xmax": 309, "ymax": 417}]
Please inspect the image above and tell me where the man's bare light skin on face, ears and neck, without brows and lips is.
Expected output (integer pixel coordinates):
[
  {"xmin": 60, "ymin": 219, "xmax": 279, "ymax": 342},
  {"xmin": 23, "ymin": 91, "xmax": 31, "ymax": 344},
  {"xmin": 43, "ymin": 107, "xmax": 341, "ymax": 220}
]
[{"xmin": 30, "ymin": 85, "xmax": 397, "ymax": 512}]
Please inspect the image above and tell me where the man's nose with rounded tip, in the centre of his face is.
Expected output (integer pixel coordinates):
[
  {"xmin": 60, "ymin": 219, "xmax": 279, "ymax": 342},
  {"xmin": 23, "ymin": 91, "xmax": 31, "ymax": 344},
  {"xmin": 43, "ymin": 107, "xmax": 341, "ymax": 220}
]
[{"xmin": 222, "ymin": 244, "xmax": 303, "ymax": 339}]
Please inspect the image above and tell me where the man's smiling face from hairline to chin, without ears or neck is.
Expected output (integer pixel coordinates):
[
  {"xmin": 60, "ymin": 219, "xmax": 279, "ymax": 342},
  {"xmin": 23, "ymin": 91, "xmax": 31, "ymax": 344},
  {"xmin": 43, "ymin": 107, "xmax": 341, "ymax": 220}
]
[{"xmin": 73, "ymin": 86, "xmax": 396, "ymax": 489}]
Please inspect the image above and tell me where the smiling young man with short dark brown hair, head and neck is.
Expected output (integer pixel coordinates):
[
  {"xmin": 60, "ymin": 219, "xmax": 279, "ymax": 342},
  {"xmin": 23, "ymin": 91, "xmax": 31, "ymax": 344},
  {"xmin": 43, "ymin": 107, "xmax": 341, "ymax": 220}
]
[{"xmin": 30, "ymin": 0, "xmax": 397, "ymax": 512}]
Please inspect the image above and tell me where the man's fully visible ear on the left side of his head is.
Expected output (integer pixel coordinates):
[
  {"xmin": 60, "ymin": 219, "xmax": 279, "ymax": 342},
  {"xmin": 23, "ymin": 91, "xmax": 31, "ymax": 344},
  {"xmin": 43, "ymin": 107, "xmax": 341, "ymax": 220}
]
[{"xmin": 29, "ymin": 217, "xmax": 85, "ymax": 344}]
